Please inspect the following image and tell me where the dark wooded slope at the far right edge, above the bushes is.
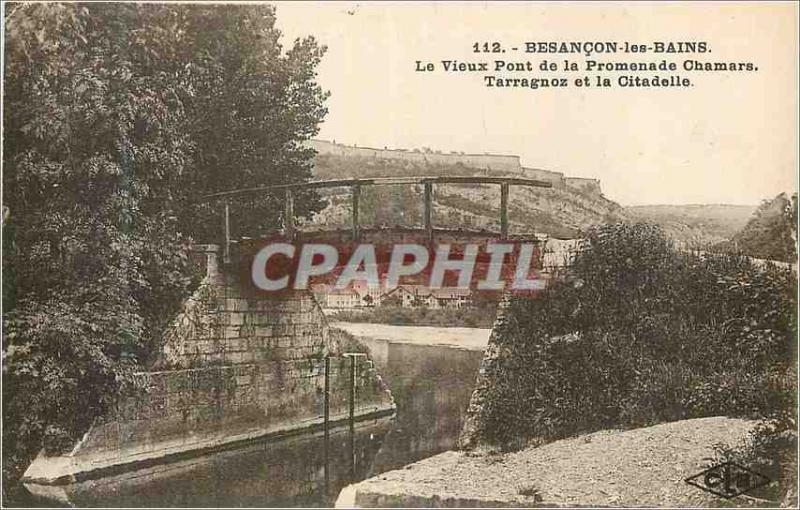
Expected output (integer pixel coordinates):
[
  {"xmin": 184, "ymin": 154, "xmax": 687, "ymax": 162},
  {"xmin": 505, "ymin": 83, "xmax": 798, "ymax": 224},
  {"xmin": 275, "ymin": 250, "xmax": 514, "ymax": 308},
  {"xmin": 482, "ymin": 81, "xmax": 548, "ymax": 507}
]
[{"xmin": 714, "ymin": 193, "xmax": 797, "ymax": 262}]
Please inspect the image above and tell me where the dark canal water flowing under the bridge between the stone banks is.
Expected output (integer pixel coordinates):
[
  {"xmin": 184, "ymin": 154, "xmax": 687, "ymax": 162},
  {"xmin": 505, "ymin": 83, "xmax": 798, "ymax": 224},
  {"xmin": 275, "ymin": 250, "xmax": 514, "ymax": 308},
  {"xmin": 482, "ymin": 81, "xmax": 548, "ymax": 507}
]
[{"xmin": 25, "ymin": 343, "xmax": 483, "ymax": 507}]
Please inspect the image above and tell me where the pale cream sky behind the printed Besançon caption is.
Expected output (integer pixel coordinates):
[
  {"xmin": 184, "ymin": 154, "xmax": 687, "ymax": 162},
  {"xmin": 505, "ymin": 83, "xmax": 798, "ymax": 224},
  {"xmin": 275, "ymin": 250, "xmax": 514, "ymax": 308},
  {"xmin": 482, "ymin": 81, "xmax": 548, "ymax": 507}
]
[{"xmin": 277, "ymin": 2, "xmax": 798, "ymax": 205}]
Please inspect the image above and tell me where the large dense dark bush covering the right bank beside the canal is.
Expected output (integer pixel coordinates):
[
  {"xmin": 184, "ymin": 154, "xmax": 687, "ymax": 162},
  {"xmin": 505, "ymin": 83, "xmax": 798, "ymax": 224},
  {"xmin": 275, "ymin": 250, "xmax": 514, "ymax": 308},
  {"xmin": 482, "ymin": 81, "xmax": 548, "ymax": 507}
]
[{"xmin": 477, "ymin": 224, "xmax": 797, "ymax": 445}]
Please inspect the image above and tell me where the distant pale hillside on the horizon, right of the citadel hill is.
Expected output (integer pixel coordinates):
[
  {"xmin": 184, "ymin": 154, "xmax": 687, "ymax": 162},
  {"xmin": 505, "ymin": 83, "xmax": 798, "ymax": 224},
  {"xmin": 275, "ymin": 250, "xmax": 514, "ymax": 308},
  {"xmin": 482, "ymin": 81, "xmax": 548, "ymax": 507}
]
[{"xmin": 625, "ymin": 204, "xmax": 755, "ymax": 248}]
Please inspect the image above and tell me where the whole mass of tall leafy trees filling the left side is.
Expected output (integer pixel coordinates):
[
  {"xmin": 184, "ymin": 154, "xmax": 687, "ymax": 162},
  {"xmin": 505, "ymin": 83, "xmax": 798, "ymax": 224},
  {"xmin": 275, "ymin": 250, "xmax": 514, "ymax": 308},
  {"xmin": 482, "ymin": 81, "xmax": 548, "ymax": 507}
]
[{"xmin": 3, "ymin": 3, "xmax": 326, "ymax": 487}]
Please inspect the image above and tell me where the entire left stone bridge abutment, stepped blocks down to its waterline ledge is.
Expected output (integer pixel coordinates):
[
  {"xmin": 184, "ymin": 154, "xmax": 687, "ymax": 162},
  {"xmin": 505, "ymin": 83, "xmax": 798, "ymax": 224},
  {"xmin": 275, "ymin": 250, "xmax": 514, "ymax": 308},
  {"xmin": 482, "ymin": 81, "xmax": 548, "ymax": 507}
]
[{"xmin": 23, "ymin": 247, "xmax": 394, "ymax": 493}]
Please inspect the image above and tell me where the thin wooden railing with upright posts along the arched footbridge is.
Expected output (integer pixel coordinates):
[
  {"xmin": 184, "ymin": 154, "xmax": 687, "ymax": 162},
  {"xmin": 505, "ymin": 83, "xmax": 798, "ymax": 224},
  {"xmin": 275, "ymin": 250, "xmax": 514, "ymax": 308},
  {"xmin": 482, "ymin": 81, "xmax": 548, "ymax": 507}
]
[{"xmin": 203, "ymin": 176, "xmax": 552, "ymax": 262}]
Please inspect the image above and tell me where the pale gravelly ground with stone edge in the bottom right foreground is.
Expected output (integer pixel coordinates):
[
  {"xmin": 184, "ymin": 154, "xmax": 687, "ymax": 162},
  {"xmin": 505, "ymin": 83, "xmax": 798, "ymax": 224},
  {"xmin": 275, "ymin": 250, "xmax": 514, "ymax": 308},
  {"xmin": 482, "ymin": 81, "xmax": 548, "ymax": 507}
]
[{"xmin": 337, "ymin": 417, "xmax": 754, "ymax": 507}]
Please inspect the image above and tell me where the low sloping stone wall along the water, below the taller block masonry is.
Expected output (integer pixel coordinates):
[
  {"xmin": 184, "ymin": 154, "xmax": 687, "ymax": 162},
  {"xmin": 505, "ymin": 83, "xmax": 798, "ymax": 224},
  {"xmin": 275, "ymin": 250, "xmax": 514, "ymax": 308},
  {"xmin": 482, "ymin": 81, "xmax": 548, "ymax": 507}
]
[{"xmin": 72, "ymin": 357, "xmax": 389, "ymax": 463}]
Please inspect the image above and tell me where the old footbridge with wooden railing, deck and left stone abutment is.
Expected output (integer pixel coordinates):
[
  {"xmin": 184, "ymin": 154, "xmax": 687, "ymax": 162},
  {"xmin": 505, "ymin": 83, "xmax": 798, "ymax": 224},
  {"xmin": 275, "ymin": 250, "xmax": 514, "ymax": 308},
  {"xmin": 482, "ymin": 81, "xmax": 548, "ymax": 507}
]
[{"xmin": 23, "ymin": 177, "xmax": 564, "ymax": 501}]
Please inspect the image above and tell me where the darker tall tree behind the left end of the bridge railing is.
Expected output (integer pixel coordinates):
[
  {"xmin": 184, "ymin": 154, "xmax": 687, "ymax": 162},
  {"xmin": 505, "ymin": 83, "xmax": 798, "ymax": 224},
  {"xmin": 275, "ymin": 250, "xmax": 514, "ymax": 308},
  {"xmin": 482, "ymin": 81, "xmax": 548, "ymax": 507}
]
[{"xmin": 162, "ymin": 6, "xmax": 327, "ymax": 239}]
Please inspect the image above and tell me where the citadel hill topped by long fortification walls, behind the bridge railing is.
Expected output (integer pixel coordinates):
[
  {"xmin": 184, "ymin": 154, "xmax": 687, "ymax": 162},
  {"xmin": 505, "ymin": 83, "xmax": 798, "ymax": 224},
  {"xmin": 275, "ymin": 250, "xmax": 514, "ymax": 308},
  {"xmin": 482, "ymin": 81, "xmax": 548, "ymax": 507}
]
[{"xmin": 306, "ymin": 137, "xmax": 629, "ymax": 238}]
